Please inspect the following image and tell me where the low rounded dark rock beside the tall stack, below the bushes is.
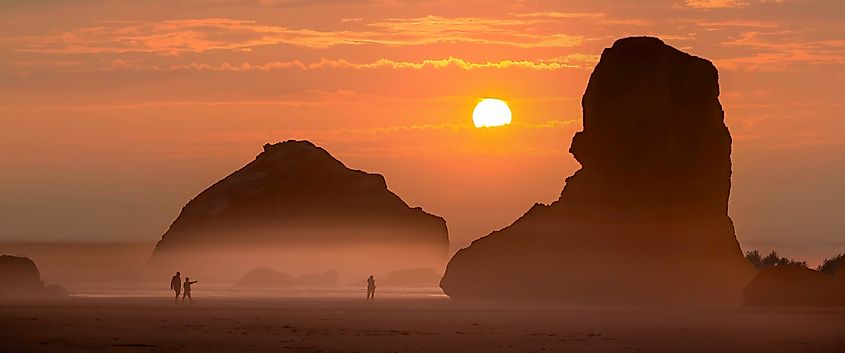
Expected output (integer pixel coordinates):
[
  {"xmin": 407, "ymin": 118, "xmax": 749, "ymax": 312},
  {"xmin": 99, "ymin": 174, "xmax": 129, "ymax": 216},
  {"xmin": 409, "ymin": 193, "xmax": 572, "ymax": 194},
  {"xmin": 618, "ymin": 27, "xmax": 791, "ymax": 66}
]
[{"xmin": 744, "ymin": 265, "xmax": 845, "ymax": 307}]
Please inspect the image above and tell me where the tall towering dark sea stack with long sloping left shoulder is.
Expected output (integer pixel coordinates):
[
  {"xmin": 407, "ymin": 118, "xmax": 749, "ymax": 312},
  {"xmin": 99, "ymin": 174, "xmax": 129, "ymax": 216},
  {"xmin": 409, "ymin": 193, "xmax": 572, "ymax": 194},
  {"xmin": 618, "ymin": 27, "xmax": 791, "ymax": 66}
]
[{"xmin": 441, "ymin": 37, "xmax": 753, "ymax": 305}]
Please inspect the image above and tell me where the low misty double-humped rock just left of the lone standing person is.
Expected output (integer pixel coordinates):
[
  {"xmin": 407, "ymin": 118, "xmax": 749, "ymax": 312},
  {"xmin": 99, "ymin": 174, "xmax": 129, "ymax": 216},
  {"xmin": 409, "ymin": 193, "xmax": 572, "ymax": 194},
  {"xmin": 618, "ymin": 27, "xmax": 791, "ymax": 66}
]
[{"xmin": 235, "ymin": 267, "xmax": 338, "ymax": 288}]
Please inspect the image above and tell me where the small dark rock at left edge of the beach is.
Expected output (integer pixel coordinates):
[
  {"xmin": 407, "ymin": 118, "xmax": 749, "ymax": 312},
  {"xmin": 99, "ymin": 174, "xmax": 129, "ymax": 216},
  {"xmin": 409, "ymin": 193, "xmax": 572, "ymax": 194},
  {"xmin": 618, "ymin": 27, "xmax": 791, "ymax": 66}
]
[{"xmin": 0, "ymin": 255, "xmax": 67, "ymax": 297}]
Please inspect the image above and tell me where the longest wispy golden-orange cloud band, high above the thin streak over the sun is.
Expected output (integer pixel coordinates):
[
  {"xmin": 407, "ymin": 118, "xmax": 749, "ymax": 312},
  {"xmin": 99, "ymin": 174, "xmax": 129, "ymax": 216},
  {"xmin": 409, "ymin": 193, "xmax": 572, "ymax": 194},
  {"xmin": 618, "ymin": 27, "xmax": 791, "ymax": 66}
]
[{"xmin": 0, "ymin": 16, "xmax": 583, "ymax": 55}]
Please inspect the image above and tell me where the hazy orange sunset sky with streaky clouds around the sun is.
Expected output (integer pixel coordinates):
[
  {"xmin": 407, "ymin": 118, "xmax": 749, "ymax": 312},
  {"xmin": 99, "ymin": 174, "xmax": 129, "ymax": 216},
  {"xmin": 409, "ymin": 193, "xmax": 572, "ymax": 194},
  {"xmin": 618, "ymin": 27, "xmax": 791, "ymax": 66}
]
[{"xmin": 0, "ymin": 0, "xmax": 845, "ymax": 262}]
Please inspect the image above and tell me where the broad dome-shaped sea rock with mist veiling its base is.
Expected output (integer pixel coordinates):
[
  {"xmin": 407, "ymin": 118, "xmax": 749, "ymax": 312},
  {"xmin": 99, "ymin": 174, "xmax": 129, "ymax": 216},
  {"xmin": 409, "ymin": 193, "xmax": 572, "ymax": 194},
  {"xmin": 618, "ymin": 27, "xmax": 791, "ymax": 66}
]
[{"xmin": 152, "ymin": 140, "xmax": 449, "ymax": 275}]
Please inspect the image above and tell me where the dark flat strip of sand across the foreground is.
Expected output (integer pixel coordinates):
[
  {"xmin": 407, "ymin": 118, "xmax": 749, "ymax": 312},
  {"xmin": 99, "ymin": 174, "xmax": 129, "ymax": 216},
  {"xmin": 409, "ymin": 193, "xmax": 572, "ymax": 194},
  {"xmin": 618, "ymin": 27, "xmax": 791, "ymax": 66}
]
[{"xmin": 0, "ymin": 297, "xmax": 845, "ymax": 353}]
